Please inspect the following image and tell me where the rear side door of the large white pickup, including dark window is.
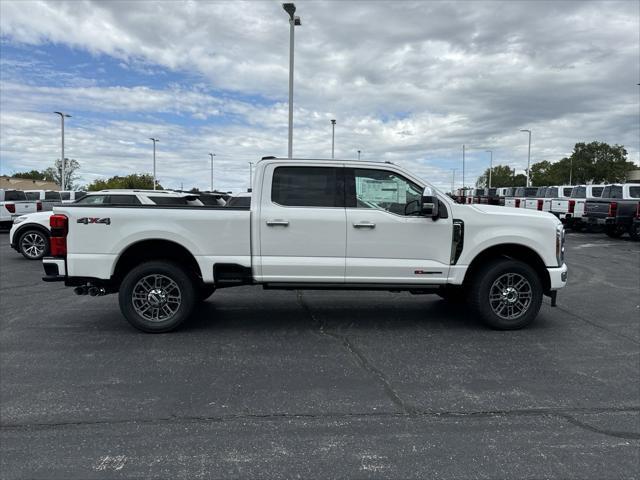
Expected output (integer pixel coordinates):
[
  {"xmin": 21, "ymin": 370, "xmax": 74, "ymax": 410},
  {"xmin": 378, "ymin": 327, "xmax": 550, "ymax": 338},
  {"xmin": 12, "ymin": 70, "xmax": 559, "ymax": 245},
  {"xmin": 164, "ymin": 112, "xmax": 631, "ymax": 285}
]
[{"xmin": 256, "ymin": 164, "xmax": 346, "ymax": 283}]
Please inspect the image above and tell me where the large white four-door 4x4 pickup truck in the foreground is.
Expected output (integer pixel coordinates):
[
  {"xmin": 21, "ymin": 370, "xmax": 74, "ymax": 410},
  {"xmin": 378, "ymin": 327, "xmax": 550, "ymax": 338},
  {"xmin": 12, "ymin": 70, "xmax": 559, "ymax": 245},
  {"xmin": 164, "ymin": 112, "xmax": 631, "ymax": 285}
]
[{"xmin": 43, "ymin": 157, "xmax": 567, "ymax": 332}]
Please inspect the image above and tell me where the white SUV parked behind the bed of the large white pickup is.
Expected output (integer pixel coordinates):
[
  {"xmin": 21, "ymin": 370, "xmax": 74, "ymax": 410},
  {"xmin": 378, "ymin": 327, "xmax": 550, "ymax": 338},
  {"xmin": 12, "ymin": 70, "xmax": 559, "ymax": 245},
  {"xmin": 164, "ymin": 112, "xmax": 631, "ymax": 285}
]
[{"xmin": 9, "ymin": 190, "xmax": 202, "ymax": 260}]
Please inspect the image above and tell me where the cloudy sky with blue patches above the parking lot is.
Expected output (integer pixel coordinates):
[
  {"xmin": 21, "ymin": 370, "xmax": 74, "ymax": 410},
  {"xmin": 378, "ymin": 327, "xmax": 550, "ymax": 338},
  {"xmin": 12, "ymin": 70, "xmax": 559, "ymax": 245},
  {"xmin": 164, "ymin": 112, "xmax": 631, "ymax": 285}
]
[{"xmin": 0, "ymin": 0, "xmax": 640, "ymax": 191}]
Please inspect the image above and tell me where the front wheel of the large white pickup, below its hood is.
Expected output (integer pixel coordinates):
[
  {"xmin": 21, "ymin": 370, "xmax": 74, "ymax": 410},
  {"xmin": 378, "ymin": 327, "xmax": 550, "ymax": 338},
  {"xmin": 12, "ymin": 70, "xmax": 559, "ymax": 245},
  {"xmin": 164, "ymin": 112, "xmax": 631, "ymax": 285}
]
[{"xmin": 470, "ymin": 259, "xmax": 543, "ymax": 330}]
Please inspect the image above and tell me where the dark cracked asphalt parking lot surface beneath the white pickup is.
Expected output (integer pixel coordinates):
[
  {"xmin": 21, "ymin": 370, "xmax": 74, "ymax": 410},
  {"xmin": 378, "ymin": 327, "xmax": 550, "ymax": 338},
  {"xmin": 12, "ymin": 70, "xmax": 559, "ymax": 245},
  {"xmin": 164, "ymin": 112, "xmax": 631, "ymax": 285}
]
[{"xmin": 0, "ymin": 233, "xmax": 640, "ymax": 479}]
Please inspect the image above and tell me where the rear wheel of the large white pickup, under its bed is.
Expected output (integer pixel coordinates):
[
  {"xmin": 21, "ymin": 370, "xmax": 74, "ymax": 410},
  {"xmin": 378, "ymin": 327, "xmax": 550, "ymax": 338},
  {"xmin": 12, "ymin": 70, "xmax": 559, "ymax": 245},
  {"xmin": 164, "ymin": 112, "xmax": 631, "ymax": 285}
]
[{"xmin": 118, "ymin": 261, "xmax": 199, "ymax": 333}]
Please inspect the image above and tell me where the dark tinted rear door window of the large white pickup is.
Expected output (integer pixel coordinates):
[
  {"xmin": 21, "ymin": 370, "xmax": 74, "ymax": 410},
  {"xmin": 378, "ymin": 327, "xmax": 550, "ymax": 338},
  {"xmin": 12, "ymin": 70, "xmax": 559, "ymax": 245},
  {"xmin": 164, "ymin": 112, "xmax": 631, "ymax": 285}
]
[{"xmin": 271, "ymin": 167, "xmax": 344, "ymax": 207}]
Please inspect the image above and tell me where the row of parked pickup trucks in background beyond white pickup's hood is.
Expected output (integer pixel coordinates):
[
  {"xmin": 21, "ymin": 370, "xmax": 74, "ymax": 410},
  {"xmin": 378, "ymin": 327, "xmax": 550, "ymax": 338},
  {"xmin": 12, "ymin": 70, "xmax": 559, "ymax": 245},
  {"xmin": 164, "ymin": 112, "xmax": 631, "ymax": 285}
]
[{"xmin": 453, "ymin": 183, "xmax": 640, "ymax": 240}]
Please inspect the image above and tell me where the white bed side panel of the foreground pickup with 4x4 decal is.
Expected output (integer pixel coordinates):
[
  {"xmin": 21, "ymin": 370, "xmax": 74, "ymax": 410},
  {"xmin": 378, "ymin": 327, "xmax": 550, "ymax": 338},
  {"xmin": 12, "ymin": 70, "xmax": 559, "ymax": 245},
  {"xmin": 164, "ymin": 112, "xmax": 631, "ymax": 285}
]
[{"xmin": 53, "ymin": 204, "xmax": 251, "ymax": 281}]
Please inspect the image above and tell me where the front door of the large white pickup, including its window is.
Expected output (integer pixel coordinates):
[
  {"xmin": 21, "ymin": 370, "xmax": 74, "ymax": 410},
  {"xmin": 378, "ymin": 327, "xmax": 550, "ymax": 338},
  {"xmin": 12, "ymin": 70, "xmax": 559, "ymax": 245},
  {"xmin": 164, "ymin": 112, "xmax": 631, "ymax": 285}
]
[{"xmin": 345, "ymin": 167, "xmax": 453, "ymax": 284}]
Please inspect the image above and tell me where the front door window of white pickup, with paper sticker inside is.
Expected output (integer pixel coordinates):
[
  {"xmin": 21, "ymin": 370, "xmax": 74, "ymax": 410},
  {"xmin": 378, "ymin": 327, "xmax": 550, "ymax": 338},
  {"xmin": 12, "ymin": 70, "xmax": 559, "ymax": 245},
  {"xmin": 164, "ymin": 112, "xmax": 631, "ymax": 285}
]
[{"xmin": 354, "ymin": 168, "xmax": 423, "ymax": 215}]
